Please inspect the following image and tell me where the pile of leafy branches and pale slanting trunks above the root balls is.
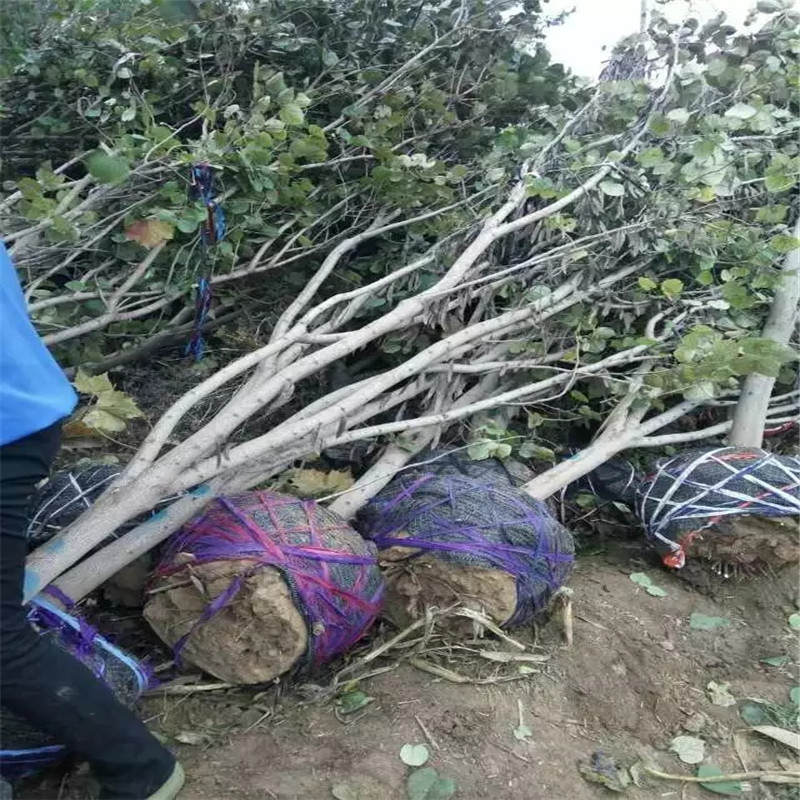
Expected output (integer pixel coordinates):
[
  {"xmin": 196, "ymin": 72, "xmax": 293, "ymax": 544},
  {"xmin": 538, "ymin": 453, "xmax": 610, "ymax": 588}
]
[{"xmin": 2, "ymin": 0, "xmax": 800, "ymax": 598}]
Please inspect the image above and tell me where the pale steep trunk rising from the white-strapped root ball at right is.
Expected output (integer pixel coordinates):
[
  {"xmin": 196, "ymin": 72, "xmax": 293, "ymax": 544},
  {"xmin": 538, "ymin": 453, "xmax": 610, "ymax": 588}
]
[{"xmin": 728, "ymin": 219, "xmax": 800, "ymax": 447}]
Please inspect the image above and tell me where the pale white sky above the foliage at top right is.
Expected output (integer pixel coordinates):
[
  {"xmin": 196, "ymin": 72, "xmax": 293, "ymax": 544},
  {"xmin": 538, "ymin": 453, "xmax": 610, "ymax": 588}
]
[{"xmin": 544, "ymin": 0, "xmax": 784, "ymax": 78}]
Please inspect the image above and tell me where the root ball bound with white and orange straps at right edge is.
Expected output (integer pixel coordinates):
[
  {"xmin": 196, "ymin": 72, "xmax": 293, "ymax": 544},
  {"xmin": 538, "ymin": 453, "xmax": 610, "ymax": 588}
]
[{"xmin": 636, "ymin": 447, "xmax": 800, "ymax": 577}]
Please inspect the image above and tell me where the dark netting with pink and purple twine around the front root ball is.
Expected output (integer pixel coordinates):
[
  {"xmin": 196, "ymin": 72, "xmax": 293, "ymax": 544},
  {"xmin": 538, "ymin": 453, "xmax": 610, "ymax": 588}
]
[{"xmin": 156, "ymin": 492, "xmax": 383, "ymax": 667}]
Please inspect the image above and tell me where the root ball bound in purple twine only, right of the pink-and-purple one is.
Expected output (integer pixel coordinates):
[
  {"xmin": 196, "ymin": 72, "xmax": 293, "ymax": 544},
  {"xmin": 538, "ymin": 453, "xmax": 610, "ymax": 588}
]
[{"xmin": 358, "ymin": 455, "xmax": 574, "ymax": 633}]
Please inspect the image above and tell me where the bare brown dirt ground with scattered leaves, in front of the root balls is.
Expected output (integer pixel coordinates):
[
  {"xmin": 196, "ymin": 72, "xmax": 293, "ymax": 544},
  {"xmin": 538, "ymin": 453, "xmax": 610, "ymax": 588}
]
[{"xmin": 19, "ymin": 543, "xmax": 798, "ymax": 800}]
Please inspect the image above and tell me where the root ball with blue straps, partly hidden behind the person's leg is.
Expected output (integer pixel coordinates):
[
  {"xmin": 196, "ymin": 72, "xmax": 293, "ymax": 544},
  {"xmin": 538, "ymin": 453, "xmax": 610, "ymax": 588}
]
[{"xmin": 0, "ymin": 600, "xmax": 151, "ymax": 781}]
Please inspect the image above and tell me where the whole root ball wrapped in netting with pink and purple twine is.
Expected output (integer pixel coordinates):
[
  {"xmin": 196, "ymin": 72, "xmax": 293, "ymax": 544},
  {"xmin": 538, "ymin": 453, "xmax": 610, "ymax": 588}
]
[{"xmin": 144, "ymin": 492, "xmax": 383, "ymax": 684}]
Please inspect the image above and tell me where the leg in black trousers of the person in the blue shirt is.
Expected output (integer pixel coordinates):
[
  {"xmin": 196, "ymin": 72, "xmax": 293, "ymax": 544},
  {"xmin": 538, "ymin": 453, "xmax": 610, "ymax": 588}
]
[{"xmin": 0, "ymin": 422, "xmax": 180, "ymax": 800}]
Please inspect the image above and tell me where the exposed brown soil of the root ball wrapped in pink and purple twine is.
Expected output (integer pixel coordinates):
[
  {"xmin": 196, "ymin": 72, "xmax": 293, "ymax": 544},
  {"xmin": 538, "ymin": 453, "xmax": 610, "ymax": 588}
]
[{"xmin": 144, "ymin": 560, "xmax": 308, "ymax": 684}]
